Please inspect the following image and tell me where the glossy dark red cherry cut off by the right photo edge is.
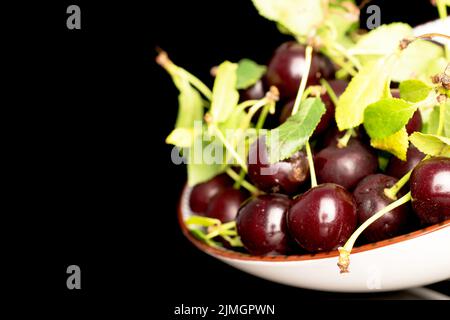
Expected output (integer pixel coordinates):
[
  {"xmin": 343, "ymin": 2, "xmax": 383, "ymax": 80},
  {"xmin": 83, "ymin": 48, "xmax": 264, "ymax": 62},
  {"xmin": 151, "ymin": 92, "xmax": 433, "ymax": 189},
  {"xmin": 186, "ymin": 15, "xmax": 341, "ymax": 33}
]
[{"xmin": 410, "ymin": 157, "xmax": 450, "ymax": 224}]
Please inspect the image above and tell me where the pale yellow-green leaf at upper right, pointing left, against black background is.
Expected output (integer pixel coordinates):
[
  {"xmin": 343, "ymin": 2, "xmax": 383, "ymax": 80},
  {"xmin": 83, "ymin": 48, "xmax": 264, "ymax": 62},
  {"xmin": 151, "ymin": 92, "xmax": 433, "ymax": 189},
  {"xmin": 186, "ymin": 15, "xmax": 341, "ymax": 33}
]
[{"xmin": 349, "ymin": 22, "xmax": 412, "ymax": 64}]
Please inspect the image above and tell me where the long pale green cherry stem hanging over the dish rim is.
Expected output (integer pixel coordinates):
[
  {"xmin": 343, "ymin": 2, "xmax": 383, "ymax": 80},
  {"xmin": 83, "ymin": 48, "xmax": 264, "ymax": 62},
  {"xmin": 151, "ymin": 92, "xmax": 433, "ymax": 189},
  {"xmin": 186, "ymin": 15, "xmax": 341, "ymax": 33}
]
[{"xmin": 338, "ymin": 192, "xmax": 411, "ymax": 273}]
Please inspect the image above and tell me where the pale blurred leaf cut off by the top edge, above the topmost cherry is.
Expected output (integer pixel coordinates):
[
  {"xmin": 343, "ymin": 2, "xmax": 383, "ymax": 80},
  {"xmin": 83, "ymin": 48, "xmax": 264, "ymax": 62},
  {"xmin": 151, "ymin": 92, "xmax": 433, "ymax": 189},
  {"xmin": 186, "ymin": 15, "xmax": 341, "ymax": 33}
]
[{"xmin": 252, "ymin": 0, "xmax": 324, "ymax": 36}]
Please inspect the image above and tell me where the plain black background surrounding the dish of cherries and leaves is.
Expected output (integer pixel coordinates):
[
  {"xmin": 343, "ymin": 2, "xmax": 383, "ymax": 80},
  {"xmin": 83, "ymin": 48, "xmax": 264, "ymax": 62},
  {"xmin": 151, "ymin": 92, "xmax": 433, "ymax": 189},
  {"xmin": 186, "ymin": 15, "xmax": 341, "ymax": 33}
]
[{"xmin": 5, "ymin": 0, "xmax": 448, "ymax": 314}]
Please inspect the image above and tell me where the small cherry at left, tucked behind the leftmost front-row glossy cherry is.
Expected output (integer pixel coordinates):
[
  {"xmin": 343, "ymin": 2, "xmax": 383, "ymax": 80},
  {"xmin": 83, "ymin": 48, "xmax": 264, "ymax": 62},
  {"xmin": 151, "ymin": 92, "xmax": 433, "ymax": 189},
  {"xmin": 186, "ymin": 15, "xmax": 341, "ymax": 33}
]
[{"xmin": 205, "ymin": 188, "xmax": 247, "ymax": 223}]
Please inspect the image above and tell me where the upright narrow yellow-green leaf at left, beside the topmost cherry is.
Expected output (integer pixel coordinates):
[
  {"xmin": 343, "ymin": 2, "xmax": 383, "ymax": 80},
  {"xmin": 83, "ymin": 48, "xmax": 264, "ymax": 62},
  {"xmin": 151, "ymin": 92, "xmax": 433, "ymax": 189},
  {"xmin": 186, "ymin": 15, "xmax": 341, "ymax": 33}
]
[{"xmin": 210, "ymin": 61, "xmax": 239, "ymax": 123}]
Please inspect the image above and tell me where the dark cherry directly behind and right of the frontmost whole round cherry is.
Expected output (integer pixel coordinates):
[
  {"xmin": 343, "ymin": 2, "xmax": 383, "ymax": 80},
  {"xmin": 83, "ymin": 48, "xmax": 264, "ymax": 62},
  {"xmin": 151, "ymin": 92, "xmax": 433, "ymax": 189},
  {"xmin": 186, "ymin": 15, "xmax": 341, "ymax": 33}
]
[{"xmin": 314, "ymin": 138, "xmax": 378, "ymax": 190}]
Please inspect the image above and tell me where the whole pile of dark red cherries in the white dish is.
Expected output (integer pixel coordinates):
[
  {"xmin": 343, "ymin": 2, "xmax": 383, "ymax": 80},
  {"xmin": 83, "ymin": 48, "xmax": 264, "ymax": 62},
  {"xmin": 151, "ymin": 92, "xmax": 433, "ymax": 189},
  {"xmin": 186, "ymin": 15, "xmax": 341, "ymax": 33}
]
[{"xmin": 189, "ymin": 42, "xmax": 450, "ymax": 255}]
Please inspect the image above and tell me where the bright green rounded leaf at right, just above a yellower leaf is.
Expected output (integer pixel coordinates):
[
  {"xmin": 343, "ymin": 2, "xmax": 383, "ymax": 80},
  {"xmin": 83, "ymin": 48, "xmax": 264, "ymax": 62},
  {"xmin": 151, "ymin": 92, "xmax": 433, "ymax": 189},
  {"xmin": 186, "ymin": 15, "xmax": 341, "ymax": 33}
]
[{"xmin": 364, "ymin": 98, "xmax": 417, "ymax": 139}]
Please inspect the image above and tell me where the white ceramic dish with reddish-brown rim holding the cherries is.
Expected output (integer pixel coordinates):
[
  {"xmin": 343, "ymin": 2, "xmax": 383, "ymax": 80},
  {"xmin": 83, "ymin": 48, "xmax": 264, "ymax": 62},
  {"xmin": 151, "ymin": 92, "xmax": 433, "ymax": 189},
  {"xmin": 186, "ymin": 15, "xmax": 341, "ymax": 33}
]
[{"xmin": 179, "ymin": 188, "xmax": 450, "ymax": 292}]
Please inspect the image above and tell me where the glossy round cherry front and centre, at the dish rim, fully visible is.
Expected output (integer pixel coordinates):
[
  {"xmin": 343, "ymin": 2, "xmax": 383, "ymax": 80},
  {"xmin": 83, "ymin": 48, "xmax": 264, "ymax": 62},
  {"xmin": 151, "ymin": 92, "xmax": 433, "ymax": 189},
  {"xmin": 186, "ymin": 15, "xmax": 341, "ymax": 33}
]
[{"xmin": 287, "ymin": 183, "xmax": 357, "ymax": 252}]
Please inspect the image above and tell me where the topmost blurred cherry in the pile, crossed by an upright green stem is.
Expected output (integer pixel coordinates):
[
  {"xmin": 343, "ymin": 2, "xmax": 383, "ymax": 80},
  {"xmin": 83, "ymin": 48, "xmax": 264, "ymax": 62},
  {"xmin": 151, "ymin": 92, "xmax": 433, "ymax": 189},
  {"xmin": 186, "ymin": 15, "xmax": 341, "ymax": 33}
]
[{"xmin": 265, "ymin": 41, "xmax": 334, "ymax": 100}]
